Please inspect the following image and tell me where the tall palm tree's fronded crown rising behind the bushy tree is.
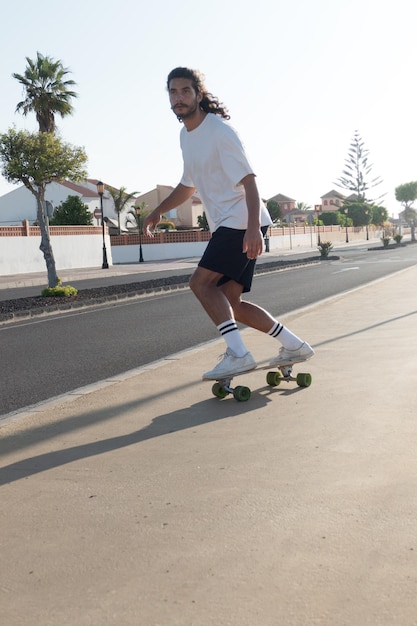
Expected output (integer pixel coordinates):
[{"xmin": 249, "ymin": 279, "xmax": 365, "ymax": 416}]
[{"xmin": 13, "ymin": 52, "xmax": 77, "ymax": 133}]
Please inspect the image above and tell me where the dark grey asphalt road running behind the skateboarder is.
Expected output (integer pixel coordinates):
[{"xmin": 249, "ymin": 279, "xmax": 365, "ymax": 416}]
[{"xmin": 0, "ymin": 246, "xmax": 417, "ymax": 415}]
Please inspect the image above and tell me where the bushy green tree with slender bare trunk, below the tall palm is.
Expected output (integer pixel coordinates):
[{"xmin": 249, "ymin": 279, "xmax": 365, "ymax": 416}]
[{"xmin": 0, "ymin": 129, "xmax": 87, "ymax": 287}]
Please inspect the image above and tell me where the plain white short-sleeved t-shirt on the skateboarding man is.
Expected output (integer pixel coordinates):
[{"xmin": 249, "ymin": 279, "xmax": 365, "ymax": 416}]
[{"xmin": 180, "ymin": 113, "xmax": 272, "ymax": 232}]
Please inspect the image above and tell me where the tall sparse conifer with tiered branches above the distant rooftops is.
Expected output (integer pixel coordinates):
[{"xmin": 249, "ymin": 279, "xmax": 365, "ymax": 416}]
[{"xmin": 335, "ymin": 130, "xmax": 382, "ymax": 204}]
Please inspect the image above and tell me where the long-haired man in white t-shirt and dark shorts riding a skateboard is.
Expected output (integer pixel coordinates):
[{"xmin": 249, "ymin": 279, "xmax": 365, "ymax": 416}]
[{"xmin": 144, "ymin": 67, "xmax": 314, "ymax": 380}]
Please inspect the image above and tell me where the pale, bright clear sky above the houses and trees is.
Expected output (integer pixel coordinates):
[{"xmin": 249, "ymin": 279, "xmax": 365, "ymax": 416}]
[{"xmin": 0, "ymin": 0, "xmax": 417, "ymax": 215}]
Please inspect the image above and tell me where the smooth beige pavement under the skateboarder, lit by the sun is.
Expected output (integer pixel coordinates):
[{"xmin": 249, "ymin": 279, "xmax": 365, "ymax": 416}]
[{"xmin": 0, "ymin": 266, "xmax": 417, "ymax": 626}]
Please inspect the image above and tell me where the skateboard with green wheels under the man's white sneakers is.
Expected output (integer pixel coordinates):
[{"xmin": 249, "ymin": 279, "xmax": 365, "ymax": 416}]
[{"xmin": 208, "ymin": 361, "xmax": 312, "ymax": 402}]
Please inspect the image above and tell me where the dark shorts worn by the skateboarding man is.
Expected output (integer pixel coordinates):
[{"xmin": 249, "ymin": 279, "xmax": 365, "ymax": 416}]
[{"xmin": 198, "ymin": 226, "xmax": 267, "ymax": 293}]
